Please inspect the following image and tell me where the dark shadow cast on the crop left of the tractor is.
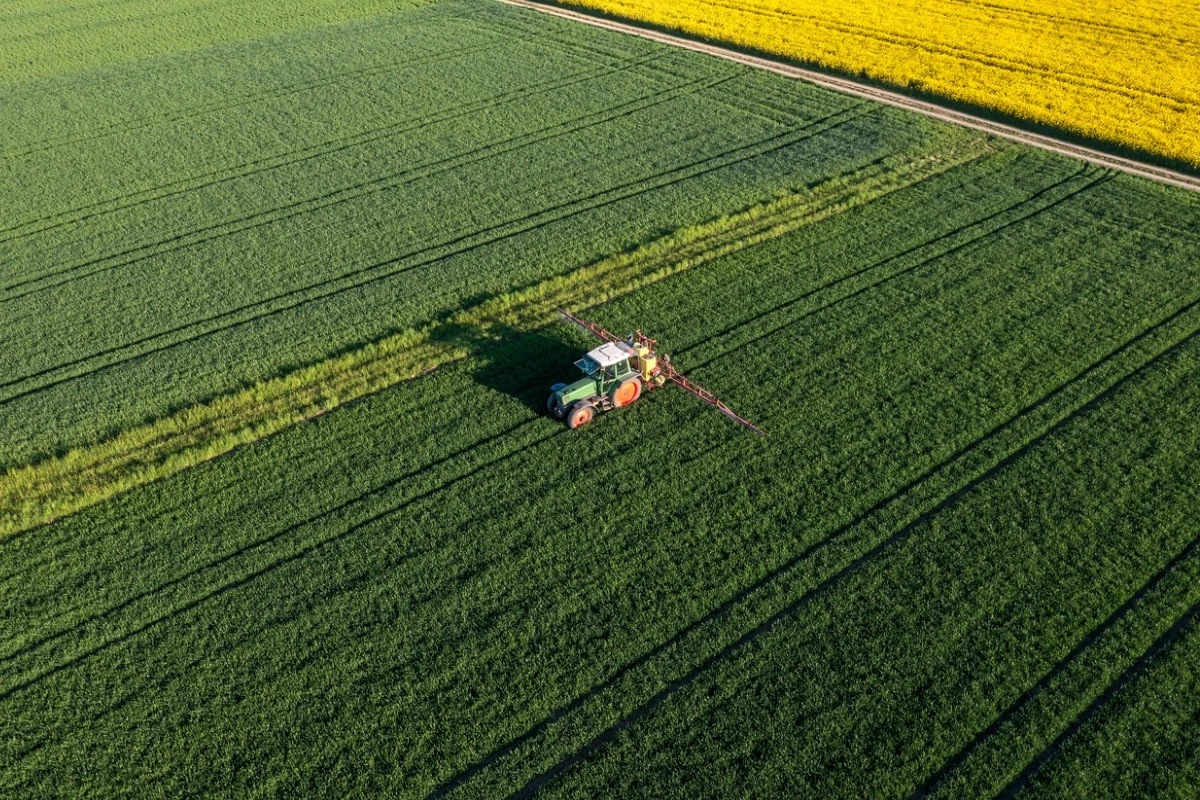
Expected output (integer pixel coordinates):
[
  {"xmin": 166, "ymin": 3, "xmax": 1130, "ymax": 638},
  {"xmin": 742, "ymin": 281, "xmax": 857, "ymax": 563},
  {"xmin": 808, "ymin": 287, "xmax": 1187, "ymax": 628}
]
[{"xmin": 474, "ymin": 329, "xmax": 584, "ymax": 414}]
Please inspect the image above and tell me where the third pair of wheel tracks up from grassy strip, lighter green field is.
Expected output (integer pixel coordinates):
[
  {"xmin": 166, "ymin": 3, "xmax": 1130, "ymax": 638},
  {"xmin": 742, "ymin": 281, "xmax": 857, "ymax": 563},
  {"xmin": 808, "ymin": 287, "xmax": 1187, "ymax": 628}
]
[{"xmin": 0, "ymin": 48, "xmax": 661, "ymax": 247}]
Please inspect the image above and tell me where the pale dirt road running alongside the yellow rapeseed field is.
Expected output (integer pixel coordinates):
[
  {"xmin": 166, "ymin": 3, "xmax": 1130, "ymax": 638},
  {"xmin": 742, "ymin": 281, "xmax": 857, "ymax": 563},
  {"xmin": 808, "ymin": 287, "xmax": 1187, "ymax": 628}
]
[{"xmin": 497, "ymin": 0, "xmax": 1200, "ymax": 192}]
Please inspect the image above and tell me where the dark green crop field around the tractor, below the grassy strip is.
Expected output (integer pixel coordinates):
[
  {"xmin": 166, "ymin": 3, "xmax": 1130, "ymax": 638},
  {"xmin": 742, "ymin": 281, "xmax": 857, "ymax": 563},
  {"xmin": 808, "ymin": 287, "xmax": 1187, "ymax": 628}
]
[{"xmin": 0, "ymin": 150, "xmax": 1200, "ymax": 796}]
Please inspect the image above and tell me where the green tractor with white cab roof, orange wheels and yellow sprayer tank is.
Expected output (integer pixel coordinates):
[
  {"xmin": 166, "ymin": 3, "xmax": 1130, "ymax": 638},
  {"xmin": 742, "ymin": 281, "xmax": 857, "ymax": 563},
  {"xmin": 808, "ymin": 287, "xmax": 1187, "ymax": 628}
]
[{"xmin": 546, "ymin": 341, "xmax": 666, "ymax": 428}]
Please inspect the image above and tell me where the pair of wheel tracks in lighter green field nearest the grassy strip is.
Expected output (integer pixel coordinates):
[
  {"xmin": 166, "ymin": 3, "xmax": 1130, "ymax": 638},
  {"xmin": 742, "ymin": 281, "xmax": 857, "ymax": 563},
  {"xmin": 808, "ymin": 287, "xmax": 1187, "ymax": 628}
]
[{"xmin": 0, "ymin": 100, "xmax": 869, "ymax": 407}]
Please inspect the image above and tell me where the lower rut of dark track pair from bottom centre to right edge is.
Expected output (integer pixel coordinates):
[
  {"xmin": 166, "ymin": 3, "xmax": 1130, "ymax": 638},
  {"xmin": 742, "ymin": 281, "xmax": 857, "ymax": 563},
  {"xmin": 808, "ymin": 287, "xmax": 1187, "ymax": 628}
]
[{"xmin": 509, "ymin": 319, "xmax": 1200, "ymax": 799}]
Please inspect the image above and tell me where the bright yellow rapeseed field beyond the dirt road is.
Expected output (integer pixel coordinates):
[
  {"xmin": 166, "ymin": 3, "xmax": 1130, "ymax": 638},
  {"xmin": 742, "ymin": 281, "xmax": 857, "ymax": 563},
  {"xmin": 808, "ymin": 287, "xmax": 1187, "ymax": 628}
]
[{"xmin": 571, "ymin": 0, "xmax": 1200, "ymax": 166}]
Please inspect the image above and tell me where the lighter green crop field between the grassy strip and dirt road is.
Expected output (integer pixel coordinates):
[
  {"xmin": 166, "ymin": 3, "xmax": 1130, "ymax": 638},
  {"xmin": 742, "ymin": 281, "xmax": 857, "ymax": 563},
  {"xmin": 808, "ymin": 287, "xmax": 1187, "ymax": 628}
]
[{"xmin": 0, "ymin": 2, "xmax": 968, "ymax": 467}]
